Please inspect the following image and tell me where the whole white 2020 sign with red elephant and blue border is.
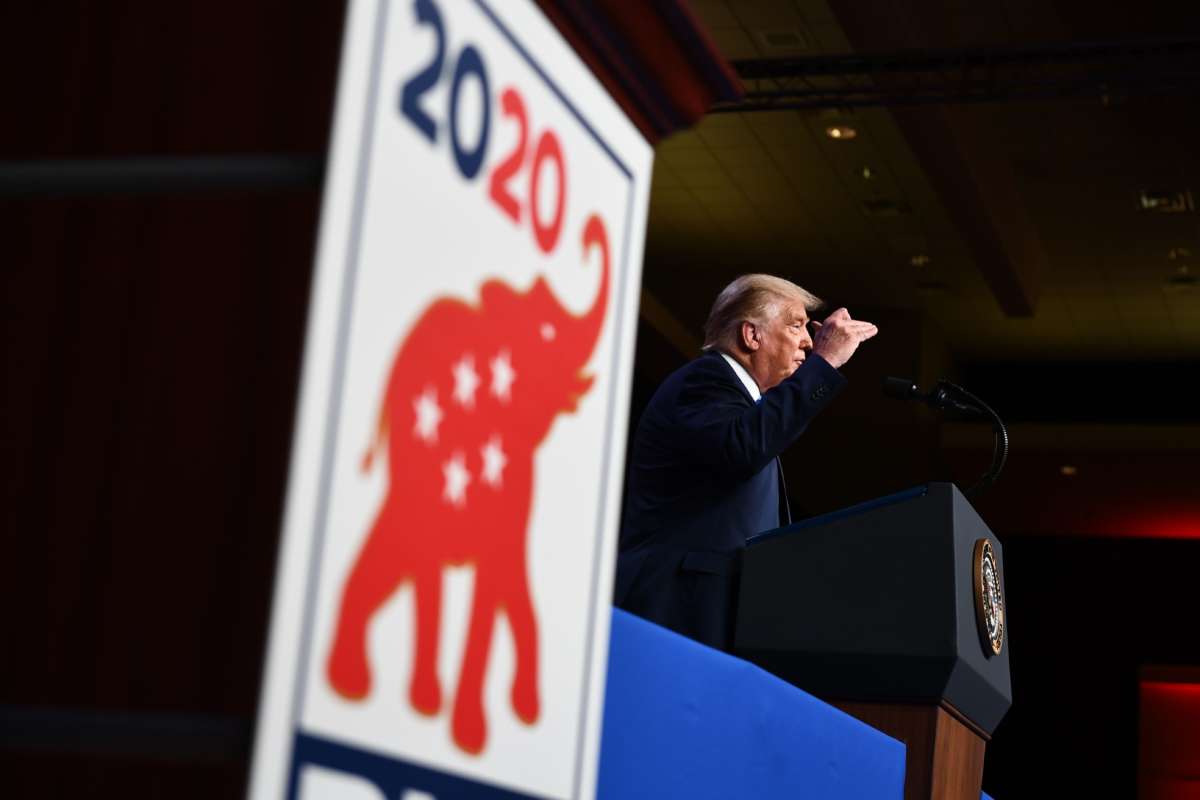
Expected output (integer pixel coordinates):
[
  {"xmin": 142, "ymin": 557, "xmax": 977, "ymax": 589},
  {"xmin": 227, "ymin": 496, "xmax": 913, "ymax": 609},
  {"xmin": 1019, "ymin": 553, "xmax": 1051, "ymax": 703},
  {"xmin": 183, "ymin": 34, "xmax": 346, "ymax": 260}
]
[{"xmin": 250, "ymin": 0, "xmax": 652, "ymax": 800}]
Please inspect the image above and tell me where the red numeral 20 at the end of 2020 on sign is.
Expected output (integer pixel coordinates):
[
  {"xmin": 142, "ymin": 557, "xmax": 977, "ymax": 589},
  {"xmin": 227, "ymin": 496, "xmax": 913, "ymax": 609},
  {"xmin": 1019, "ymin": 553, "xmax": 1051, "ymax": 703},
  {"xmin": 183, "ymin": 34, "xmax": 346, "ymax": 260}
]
[{"xmin": 488, "ymin": 89, "xmax": 566, "ymax": 253}]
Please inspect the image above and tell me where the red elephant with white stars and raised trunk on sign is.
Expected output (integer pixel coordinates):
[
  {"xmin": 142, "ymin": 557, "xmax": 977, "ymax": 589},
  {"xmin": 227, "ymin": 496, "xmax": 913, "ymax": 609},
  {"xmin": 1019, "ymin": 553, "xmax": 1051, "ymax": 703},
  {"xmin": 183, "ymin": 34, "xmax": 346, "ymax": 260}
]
[{"xmin": 326, "ymin": 215, "xmax": 610, "ymax": 753}]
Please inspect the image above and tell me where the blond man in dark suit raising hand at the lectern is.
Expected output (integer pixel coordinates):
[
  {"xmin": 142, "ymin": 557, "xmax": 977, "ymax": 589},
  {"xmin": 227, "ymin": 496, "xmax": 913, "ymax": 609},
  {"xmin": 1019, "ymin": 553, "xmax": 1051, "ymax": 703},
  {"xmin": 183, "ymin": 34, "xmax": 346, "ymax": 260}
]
[{"xmin": 614, "ymin": 275, "xmax": 877, "ymax": 650}]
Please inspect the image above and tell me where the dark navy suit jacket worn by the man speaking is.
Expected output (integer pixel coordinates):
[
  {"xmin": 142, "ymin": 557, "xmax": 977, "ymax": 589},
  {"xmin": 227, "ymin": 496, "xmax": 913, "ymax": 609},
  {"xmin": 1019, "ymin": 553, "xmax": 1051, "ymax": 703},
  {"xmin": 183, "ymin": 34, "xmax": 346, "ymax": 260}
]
[{"xmin": 613, "ymin": 350, "xmax": 845, "ymax": 650}]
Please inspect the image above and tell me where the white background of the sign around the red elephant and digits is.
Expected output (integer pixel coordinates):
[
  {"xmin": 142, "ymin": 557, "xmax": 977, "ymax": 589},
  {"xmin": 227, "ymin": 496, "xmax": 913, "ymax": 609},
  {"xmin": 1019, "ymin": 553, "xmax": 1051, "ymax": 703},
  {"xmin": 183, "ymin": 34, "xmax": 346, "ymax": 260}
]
[{"xmin": 251, "ymin": 0, "xmax": 652, "ymax": 798}]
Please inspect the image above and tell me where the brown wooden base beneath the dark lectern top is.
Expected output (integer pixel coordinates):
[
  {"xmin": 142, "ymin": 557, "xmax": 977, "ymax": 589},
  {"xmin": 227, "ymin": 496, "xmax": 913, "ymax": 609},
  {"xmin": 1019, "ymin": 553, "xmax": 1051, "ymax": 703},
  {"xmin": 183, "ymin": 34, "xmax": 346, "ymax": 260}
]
[{"xmin": 829, "ymin": 700, "xmax": 990, "ymax": 800}]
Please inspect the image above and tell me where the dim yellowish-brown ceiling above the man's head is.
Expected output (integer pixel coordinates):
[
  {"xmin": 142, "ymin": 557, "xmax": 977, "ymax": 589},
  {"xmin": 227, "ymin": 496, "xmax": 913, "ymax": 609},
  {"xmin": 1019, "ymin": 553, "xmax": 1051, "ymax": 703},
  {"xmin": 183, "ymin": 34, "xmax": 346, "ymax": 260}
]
[{"xmin": 644, "ymin": 0, "xmax": 1200, "ymax": 365}]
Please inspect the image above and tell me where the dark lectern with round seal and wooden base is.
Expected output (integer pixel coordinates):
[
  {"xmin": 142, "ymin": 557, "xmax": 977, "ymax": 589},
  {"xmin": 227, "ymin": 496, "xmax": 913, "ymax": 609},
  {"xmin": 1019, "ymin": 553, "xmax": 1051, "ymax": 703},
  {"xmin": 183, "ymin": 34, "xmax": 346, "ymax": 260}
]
[{"xmin": 734, "ymin": 483, "xmax": 1013, "ymax": 800}]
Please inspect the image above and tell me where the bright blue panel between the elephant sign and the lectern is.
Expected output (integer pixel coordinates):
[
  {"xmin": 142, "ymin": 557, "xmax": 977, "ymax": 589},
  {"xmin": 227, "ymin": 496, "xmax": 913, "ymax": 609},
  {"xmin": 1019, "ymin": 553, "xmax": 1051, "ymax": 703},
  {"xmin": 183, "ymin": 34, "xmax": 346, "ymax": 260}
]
[{"xmin": 598, "ymin": 609, "xmax": 905, "ymax": 800}]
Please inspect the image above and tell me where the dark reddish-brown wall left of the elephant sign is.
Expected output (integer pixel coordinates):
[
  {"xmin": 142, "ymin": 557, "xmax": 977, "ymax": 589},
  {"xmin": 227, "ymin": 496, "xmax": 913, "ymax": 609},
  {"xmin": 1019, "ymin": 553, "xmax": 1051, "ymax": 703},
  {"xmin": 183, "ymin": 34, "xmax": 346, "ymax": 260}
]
[{"xmin": 0, "ymin": 0, "xmax": 343, "ymax": 798}]
